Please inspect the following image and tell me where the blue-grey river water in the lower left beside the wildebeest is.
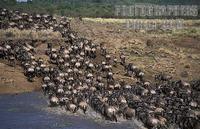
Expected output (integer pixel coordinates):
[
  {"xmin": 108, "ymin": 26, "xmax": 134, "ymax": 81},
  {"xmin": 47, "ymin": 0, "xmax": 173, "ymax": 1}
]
[{"xmin": 0, "ymin": 92, "xmax": 145, "ymax": 129}]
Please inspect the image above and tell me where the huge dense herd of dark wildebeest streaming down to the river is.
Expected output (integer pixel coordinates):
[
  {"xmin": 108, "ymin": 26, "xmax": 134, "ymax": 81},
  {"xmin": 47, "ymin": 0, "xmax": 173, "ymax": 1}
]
[{"xmin": 0, "ymin": 9, "xmax": 200, "ymax": 129}]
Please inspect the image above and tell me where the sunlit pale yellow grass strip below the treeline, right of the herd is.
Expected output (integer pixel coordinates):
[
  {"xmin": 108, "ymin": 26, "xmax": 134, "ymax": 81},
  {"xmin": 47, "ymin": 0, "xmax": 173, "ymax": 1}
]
[{"xmin": 80, "ymin": 18, "xmax": 200, "ymax": 38}]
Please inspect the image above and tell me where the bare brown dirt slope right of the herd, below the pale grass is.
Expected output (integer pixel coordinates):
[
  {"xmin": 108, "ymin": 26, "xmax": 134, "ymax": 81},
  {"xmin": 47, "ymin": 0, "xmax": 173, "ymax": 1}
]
[{"xmin": 72, "ymin": 20, "xmax": 200, "ymax": 81}]
